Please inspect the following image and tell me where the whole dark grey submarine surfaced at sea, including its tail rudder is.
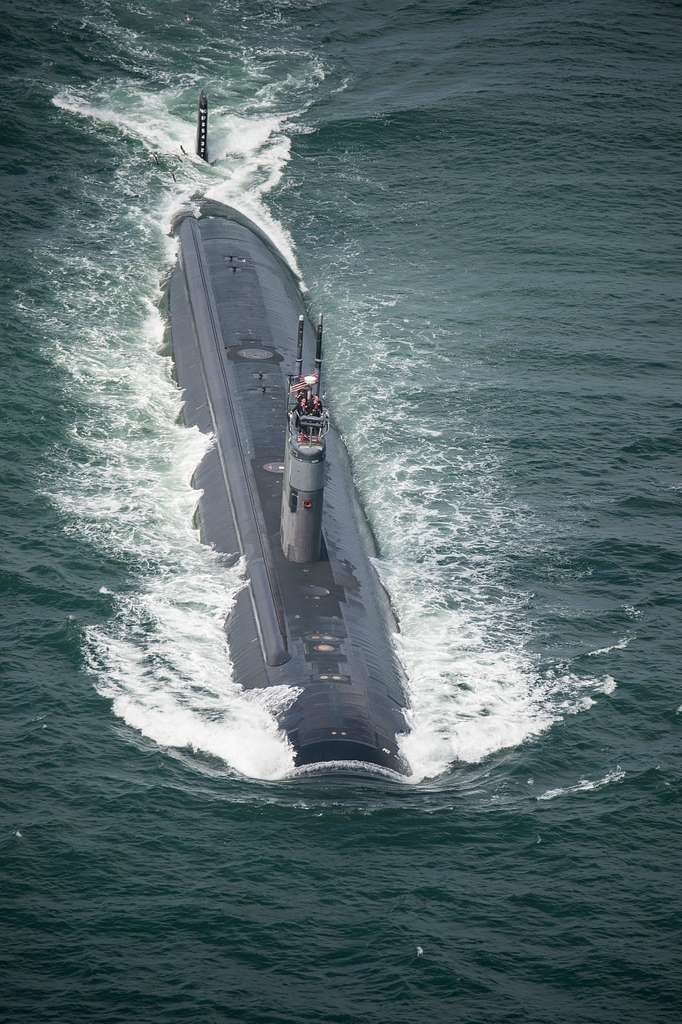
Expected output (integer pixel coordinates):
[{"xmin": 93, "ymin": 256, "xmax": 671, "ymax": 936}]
[{"xmin": 167, "ymin": 92, "xmax": 410, "ymax": 775}]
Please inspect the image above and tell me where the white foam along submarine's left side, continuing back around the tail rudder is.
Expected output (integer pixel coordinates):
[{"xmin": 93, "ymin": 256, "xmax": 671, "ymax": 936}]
[{"xmin": 48, "ymin": 54, "xmax": 319, "ymax": 779}]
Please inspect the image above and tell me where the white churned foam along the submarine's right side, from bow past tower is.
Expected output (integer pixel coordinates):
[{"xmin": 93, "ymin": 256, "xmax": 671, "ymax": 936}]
[{"xmin": 329, "ymin": 296, "xmax": 616, "ymax": 782}]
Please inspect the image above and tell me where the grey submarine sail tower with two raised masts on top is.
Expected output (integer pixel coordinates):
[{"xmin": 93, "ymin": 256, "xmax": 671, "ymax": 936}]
[{"xmin": 280, "ymin": 316, "xmax": 329, "ymax": 562}]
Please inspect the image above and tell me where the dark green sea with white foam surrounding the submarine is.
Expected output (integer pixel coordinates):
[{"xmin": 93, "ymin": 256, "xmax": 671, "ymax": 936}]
[{"xmin": 0, "ymin": 0, "xmax": 682, "ymax": 1024}]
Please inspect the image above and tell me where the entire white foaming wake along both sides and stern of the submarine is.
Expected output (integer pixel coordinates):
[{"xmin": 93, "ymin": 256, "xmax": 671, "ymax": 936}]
[{"xmin": 50, "ymin": 39, "xmax": 615, "ymax": 782}]
